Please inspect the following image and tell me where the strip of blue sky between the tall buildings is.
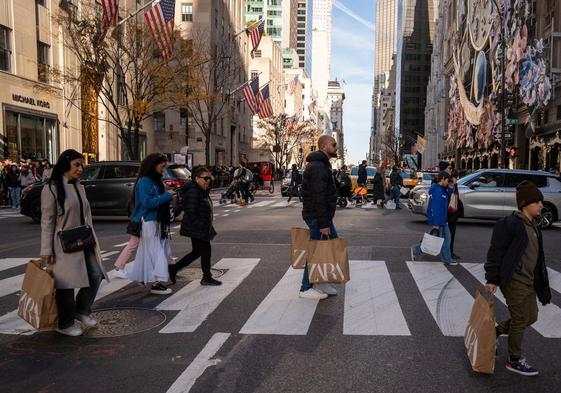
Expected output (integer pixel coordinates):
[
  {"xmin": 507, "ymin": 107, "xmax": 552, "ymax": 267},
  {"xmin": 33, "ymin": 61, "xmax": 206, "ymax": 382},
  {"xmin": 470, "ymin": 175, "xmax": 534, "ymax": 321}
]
[{"xmin": 331, "ymin": 0, "xmax": 376, "ymax": 164}]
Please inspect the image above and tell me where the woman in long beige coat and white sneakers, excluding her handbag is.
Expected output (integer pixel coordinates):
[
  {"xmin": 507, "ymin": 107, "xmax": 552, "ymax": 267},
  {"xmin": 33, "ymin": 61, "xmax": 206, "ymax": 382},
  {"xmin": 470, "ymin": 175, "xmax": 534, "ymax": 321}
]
[{"xmin": 41, "ymin": 150, "xmax": 107, "ymax": 336}]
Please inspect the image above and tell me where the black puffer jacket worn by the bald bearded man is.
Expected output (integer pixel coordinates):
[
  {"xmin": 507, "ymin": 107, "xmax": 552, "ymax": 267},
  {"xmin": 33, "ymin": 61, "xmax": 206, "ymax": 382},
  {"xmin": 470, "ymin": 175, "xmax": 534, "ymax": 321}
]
[{"xmin": 302, "ymin": 151, "xmax": 337, "ymax": 228}]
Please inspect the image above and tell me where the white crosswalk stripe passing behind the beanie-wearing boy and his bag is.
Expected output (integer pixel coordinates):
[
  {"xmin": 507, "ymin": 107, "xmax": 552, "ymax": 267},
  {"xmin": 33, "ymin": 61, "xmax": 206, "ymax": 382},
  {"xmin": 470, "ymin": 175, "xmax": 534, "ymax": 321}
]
[{"xmin": 462, "ymin": 263, "xmax": 561, "ymax": 338}]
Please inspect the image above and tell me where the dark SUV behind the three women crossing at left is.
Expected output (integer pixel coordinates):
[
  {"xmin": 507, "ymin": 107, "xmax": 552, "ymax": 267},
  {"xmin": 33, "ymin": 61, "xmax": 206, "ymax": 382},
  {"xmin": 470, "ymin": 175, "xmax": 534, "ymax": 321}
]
[{"xmin": 21, "ymin": 161, "xmax": 191, "ymax": 223}]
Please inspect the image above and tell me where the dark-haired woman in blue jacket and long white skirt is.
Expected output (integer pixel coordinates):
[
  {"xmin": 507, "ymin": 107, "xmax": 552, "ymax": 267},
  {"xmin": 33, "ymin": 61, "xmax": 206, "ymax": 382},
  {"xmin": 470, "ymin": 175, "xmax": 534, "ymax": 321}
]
[{"xmin": 126, "ymin": 153, "xmax": 175, "ymax": 295}]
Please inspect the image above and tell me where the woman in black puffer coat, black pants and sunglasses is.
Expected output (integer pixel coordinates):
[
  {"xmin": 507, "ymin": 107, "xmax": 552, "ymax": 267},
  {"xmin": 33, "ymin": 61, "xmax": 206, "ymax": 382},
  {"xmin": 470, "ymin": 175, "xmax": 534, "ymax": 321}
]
[{"xmin": 169, "ymin": 167, "xmax": 222, "ymax": 285}]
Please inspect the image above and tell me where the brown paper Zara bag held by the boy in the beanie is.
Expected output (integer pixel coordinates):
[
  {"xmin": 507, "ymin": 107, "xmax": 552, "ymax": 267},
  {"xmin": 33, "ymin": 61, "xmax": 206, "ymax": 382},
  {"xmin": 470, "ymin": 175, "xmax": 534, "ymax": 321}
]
[{"xmin": 464, "ymin": 290, "xmax": 497, "ymax": 374}]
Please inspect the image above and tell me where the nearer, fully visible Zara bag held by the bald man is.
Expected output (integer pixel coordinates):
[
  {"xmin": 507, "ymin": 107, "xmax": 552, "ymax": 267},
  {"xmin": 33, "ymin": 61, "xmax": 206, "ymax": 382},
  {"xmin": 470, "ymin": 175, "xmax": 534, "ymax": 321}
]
[{"xmin": 308, "ymin": 239, "xmax": 350, "ymax": 284}]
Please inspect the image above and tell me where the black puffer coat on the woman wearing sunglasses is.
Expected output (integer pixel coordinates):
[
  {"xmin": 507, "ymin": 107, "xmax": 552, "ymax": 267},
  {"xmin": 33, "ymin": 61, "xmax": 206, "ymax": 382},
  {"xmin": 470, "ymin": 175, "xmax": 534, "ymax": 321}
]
[{"xmin": 179, "ymin": 182, "xmax": 216, "ymax": 241}]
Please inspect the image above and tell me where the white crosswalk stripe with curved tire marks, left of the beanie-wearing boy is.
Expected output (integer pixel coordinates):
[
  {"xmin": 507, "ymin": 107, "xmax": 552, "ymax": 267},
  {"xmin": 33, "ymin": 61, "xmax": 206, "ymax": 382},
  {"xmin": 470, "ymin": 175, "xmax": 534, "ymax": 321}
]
[{"xmin": 407, "ymin": 262, "xmax": 473, "ymax": 337}]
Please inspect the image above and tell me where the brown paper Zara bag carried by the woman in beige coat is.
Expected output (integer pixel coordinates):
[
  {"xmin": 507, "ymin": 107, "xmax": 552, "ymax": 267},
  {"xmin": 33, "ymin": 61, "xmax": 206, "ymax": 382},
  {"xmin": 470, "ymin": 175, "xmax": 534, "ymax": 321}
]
[{"xmin": 18, "ymin": 260, "xmax": 58, "ymax": 330}]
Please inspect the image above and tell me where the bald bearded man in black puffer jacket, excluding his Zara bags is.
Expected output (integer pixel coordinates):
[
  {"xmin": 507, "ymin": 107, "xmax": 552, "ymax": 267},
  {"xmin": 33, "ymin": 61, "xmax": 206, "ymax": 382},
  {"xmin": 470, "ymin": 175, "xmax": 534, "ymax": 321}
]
[{"xmin": 300, "ymin": 135, "xmax": 337, "ymax": 299}]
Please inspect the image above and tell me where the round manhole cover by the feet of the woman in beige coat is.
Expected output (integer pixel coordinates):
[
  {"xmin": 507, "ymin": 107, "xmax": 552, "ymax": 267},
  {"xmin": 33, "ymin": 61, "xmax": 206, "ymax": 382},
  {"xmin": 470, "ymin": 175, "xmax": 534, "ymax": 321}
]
[{"xmin": 84, "ymin": 307, "xmax": 166, "ymax": 338}]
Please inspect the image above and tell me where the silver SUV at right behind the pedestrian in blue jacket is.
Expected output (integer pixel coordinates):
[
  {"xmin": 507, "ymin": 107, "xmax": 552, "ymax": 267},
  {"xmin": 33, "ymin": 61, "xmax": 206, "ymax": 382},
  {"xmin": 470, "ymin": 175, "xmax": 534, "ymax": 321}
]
[{"xmin": 408, "ymin": 169, "xmax": 561, "ymax": 228}]
